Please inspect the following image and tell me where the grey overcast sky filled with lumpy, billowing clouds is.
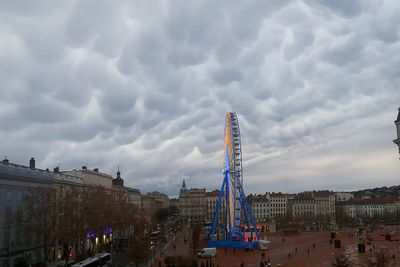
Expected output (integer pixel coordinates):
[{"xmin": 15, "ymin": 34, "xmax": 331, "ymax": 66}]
[{"xmin": 0, "ymin": 0, "xmax": 400, "ymax": 196}]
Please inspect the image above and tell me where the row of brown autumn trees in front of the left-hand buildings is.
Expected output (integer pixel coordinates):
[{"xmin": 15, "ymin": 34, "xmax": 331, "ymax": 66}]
[{"xmin": 21, "ymin": 186, "xmax": 141, "ymax": 264}]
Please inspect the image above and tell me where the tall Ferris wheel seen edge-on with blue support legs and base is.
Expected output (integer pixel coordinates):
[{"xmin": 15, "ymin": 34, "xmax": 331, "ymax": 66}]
[{"xmin": 208, "ymin": 112, "xmax": 259, "ymax": 248}]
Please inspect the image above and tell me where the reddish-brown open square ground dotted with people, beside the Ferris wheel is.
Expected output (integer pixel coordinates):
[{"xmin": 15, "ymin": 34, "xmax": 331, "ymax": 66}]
[{"xmin": 152, "ymin": 228, "xmax": 400, "ymax": 267}]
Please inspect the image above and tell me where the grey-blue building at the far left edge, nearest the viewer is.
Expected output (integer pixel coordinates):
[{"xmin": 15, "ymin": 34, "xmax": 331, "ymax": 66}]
[{"xmin": 0, "ymin": 158, "xmax": 54, "ymax": 267}]
